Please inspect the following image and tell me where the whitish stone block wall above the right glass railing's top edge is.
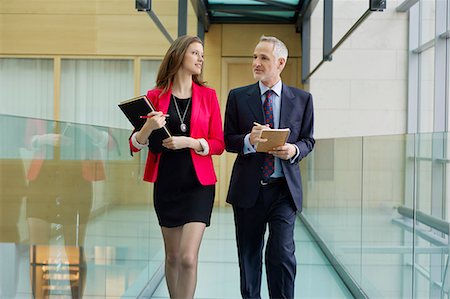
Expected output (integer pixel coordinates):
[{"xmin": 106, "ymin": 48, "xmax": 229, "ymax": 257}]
[{"xmin": 310, "ymin": 0, "xmax": 408, "ymax": 138}]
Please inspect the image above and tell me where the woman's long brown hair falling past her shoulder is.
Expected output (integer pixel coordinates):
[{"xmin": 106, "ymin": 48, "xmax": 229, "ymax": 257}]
[{"xmin": 156, "ymin": 35, "xmax": 205, "ymax": 95}]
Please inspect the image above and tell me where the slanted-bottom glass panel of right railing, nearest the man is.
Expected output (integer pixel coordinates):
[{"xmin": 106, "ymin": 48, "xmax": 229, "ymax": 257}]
[{"xmin": 301, "ymin": 138, "xmax": 362, "ymax": 283}]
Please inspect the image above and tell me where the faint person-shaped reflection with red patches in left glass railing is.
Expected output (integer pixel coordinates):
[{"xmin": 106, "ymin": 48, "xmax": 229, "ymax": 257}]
[{"xmin": 26, "ymin": 119, "xmax": 110, "ymax": 298}]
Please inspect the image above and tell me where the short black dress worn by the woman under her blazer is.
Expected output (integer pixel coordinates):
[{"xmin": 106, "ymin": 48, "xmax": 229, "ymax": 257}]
[{"xmin": 153, "ymin": 96, "xmax": 215, "ymax": 227}]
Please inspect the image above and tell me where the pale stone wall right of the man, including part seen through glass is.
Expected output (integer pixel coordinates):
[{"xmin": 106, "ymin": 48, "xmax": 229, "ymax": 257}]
[{"xmin": 302, "ymin": 0, "xmax": 408, "ymax": 213}]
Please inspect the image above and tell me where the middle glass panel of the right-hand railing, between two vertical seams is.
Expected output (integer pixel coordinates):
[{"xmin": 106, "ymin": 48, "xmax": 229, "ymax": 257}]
[{"xmin": 361, "ymin": 135, "xmax": 413, "ymax": 298}]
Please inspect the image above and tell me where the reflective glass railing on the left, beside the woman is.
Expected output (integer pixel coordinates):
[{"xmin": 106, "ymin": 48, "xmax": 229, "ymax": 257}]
[{"xmin": 0, "ymin": 115, "xmax": 163, "ymax": 298}]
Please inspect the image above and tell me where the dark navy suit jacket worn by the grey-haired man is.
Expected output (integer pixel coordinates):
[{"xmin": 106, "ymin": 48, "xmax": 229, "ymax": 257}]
[{"xmin": 224, "ymin": 83, "xmax": 315, "ymax": 211}]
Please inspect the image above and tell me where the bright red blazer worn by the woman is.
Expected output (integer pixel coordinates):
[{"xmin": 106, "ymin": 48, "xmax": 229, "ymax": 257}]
[{"xmin": 130, "ymin": 82, "xmax": 225, "ymax": 185}]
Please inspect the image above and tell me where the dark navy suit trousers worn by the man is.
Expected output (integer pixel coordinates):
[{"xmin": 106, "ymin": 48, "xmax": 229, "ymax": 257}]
[{"xmin": 233, "ymin": 182, "xmax": 297, "ymax": 299}]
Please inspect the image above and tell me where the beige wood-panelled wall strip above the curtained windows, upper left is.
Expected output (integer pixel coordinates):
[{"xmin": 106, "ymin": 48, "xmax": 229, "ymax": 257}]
[{"xmin": 0, "ymin": 0, "xmax": 197, "ymax": 56}]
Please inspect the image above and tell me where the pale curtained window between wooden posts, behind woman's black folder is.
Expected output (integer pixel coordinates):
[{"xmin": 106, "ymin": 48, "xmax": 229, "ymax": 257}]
[{"xmin": 60, "ymin": 59, "xmax": 134, "ymax": 128}]
